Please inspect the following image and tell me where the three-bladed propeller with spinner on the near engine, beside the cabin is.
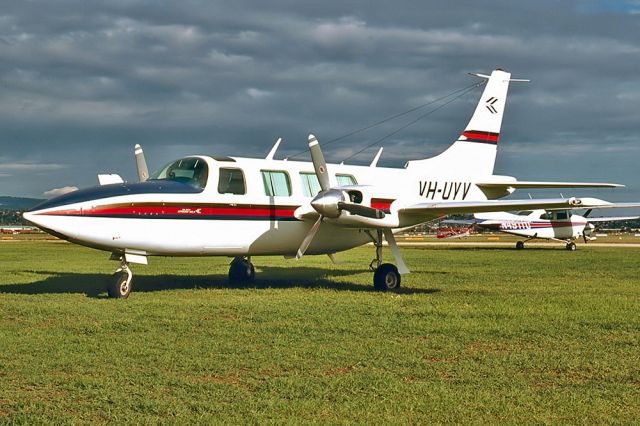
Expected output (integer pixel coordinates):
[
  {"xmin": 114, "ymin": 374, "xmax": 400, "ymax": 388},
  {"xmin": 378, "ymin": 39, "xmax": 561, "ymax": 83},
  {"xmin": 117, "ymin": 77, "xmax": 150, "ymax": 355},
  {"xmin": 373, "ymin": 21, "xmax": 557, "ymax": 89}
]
[{"xmin": 296, "ymin": 135, "xmax": 385, "ymax": 259}]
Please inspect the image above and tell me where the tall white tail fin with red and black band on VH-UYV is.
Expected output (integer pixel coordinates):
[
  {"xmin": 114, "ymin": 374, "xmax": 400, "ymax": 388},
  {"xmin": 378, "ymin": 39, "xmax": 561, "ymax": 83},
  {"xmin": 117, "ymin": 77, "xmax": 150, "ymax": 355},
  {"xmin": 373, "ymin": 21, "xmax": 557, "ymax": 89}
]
[{"xmin": 407, "ymin": 69, "xmax": 511, "ymax": 177}]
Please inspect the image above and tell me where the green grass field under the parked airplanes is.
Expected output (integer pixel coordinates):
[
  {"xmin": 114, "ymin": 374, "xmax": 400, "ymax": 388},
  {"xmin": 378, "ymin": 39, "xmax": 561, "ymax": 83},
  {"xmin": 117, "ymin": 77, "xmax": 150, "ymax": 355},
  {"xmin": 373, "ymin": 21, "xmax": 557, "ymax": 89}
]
[{"xmin": 0, "ymin": 241, "xmax": 640, "ymax": 424}]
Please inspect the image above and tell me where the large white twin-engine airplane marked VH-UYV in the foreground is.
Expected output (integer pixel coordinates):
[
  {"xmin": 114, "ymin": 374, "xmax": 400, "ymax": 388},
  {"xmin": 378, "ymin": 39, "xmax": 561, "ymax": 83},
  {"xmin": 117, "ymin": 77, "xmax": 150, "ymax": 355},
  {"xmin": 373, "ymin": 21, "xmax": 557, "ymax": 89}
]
[{"xmin": 24, "ymin": 69, "xmax": 636, "ymax": 298}]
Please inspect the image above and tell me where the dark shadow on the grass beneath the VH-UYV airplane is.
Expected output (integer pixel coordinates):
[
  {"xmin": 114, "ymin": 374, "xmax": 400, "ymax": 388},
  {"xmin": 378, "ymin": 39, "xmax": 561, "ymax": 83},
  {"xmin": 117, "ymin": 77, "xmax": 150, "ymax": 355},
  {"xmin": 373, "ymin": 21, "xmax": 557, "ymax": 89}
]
[{"xmin": 0, "ymin": 266, "xmax": 440, "ymax": 298}]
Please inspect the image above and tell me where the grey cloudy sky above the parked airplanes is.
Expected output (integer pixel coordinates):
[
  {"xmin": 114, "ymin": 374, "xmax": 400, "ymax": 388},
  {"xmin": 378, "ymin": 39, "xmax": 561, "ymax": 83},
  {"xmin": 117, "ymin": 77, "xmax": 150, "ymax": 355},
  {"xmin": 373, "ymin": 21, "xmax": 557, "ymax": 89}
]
[{"xmin": 0, "ymin": 0, "xmax": 640, "ymax": 200}]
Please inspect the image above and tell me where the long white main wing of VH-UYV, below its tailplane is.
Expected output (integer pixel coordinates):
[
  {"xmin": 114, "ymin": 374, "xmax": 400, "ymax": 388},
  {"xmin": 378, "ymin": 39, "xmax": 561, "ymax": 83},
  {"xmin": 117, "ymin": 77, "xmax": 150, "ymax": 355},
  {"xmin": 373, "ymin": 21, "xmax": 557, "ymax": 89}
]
[{"xmin": 398, "ymin": 197, "xmax": 640, "ymax": 223}]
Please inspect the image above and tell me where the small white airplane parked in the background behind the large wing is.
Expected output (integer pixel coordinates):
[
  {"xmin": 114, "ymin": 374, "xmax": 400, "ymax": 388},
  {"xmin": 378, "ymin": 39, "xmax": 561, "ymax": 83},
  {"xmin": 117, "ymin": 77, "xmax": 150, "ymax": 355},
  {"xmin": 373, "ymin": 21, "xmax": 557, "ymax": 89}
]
[{"xmin": 460, "ymin": 209, "xmax": 640, "ymax": 251}]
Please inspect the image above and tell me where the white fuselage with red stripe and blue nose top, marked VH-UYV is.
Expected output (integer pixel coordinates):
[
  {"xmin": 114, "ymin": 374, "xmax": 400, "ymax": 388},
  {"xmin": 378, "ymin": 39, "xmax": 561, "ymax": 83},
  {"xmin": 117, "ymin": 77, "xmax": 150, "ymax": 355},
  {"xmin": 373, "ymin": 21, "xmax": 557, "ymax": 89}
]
[{"xmin": 25, "ymin": 156, "xmax": 496, "ymax": 256}]
